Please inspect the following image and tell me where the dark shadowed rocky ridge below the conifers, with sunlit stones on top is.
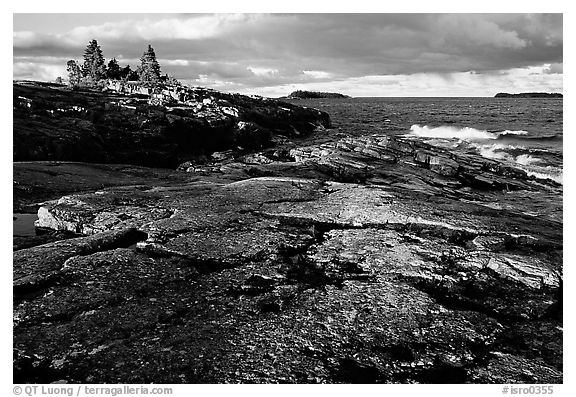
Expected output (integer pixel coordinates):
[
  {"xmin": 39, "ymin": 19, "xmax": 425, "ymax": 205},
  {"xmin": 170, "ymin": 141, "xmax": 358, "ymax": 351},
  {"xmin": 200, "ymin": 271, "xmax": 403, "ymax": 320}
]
[{"xmin": 13, "ymin": 82, "xmax": 330, "ymax": 168}]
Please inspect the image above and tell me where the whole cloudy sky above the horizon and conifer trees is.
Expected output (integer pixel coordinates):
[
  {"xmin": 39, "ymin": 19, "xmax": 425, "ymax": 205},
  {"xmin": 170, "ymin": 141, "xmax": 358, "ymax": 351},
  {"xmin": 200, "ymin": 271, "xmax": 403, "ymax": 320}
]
[{"xmin": 13, "ymin": 13, "xmax": 563, "ymax": 97}]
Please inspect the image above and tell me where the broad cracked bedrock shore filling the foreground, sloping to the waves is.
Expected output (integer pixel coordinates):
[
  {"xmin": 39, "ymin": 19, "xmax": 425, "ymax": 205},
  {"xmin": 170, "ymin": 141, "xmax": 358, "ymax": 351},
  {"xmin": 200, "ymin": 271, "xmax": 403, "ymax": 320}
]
[{"xmin": 14, "ymin": 82, "xmax": 563, "ymax": 383}]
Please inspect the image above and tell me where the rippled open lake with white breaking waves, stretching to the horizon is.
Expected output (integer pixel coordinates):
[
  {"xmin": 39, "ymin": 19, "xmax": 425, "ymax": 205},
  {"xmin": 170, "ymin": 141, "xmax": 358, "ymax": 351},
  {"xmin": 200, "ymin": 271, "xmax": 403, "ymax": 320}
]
[{"xmin": 292, "ymin": 98, "xmax": 563, "ymax": 183}]
